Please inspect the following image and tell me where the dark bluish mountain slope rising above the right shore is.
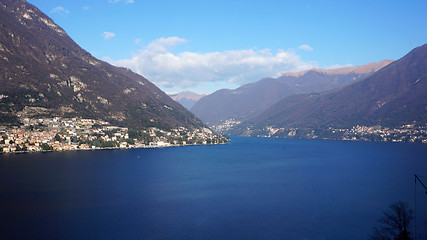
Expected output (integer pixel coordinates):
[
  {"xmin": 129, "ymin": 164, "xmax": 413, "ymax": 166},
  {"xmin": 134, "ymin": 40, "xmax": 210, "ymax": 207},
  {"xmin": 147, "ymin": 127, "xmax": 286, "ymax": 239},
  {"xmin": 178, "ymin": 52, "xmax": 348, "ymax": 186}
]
[{"xmin": 239, "ymin": 44, "xmax": 427, "ymax": 131}]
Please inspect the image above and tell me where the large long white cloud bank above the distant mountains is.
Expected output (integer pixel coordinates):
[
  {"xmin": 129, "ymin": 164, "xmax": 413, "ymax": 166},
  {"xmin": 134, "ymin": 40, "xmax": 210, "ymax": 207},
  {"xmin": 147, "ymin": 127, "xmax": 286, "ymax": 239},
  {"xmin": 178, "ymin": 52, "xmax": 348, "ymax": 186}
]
[{"xmin": 105, "ymin": 37, "xmax": 317, "ymax": 88}]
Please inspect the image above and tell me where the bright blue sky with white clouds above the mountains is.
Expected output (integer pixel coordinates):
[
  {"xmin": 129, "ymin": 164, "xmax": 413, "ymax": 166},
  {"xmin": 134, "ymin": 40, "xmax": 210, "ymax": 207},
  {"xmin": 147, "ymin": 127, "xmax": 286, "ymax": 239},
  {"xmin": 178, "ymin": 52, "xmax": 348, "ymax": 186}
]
[{"xmin": 27, "ymin": 0, "xmax": 427, "ymax": 93}]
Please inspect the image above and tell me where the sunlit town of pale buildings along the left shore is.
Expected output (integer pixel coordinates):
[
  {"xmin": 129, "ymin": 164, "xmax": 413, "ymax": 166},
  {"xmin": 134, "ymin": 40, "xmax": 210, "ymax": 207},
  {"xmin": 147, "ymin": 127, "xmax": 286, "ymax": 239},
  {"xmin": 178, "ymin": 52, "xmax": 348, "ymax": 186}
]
[{"xmin": 0, "ymin": 117, "xmax": 228, "ymax": 153}]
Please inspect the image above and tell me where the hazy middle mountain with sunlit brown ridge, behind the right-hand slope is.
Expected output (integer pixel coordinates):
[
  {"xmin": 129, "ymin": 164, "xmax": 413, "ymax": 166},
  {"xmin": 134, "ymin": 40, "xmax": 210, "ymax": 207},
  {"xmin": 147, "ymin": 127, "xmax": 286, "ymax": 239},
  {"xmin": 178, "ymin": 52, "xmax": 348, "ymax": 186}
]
[{"xmin": 190, "ymin": 60, "xmax": 392, "ymax": 125}]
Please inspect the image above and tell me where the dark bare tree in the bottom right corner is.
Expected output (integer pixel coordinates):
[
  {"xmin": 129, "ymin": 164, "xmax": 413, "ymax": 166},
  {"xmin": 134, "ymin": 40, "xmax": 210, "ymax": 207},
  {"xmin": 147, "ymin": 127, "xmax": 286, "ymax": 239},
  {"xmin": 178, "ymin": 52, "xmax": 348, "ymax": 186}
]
[{"xmin": 371, "ymin": 201, "xmax": 413, "ymax": 240}]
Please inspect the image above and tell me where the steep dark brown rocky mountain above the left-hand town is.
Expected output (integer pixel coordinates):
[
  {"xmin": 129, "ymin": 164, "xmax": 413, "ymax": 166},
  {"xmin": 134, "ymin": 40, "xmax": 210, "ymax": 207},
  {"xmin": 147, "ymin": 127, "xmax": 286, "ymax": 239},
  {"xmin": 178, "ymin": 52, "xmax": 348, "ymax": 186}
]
[{"xmin": 0, "ymin": 0, "xmax": 203, "ymax": 128}]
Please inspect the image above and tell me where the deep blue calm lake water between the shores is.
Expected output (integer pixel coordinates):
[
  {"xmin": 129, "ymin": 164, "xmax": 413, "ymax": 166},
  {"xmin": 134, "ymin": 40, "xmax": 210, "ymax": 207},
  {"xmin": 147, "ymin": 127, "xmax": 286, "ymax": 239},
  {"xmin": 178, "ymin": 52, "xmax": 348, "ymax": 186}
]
[{"xmin": 0, "ymin": 137, "xmax": 427, "ymax": 240}]
